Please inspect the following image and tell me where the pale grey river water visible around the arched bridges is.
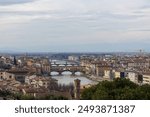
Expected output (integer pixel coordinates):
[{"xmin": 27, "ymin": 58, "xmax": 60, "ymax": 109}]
[{"xmin": 51, "ymin": 60, "xmax": 96, "ymax": 85}]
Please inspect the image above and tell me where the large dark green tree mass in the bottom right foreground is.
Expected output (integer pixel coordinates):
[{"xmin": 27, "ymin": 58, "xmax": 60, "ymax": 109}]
[{"xmin": 81, "ymin": 78, "xmax": 150, "ymax": 100}]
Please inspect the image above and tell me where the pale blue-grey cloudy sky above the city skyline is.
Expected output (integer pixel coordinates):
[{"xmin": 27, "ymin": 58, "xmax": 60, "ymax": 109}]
[{"xmin": 0, "ymin": 0, "xmax": 150, "ymax": 52}]
